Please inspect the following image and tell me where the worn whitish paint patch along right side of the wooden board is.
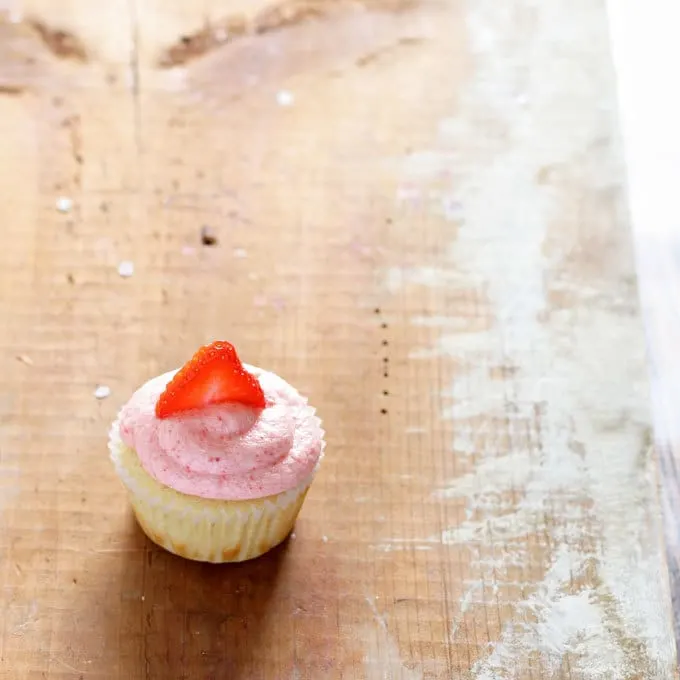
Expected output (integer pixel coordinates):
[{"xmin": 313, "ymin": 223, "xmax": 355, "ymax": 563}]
[{"xmin": 396, "ymin": 0, "xmax": 674, "ymax": 680}]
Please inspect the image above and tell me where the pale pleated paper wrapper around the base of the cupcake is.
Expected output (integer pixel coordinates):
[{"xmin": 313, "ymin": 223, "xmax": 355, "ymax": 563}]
[{"xmin": 109, "ymin": 407, "xmax": 325, "ymax": 562}]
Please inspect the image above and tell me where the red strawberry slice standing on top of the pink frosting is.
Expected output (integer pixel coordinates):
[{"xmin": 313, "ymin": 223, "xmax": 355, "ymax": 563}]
[{"xmin": 156, "ymin": 342, "xmax": 265, "ymax": 418}]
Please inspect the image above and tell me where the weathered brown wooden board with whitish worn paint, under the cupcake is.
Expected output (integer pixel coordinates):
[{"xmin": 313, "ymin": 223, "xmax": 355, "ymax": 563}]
[{"xmin": 0, "ymin": 0, "xmax": 676, "ymax": 680}]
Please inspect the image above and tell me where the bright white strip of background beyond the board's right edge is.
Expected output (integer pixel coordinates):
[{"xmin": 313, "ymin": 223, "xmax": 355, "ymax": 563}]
[{"xmin": 609, "ymin": 0, "xmax": 680, "ymax": 646}]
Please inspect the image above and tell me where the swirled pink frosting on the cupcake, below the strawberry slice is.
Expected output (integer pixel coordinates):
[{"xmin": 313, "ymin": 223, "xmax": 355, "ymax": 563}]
[{"xmin": 119, "ymin": 366, "xmax": 323, "ymax": 500}]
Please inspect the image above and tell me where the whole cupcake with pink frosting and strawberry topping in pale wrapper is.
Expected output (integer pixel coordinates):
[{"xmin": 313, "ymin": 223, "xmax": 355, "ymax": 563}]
[{"xmin": 109, "ymin": 342, "xmax": 324, "ymax": 562}]
